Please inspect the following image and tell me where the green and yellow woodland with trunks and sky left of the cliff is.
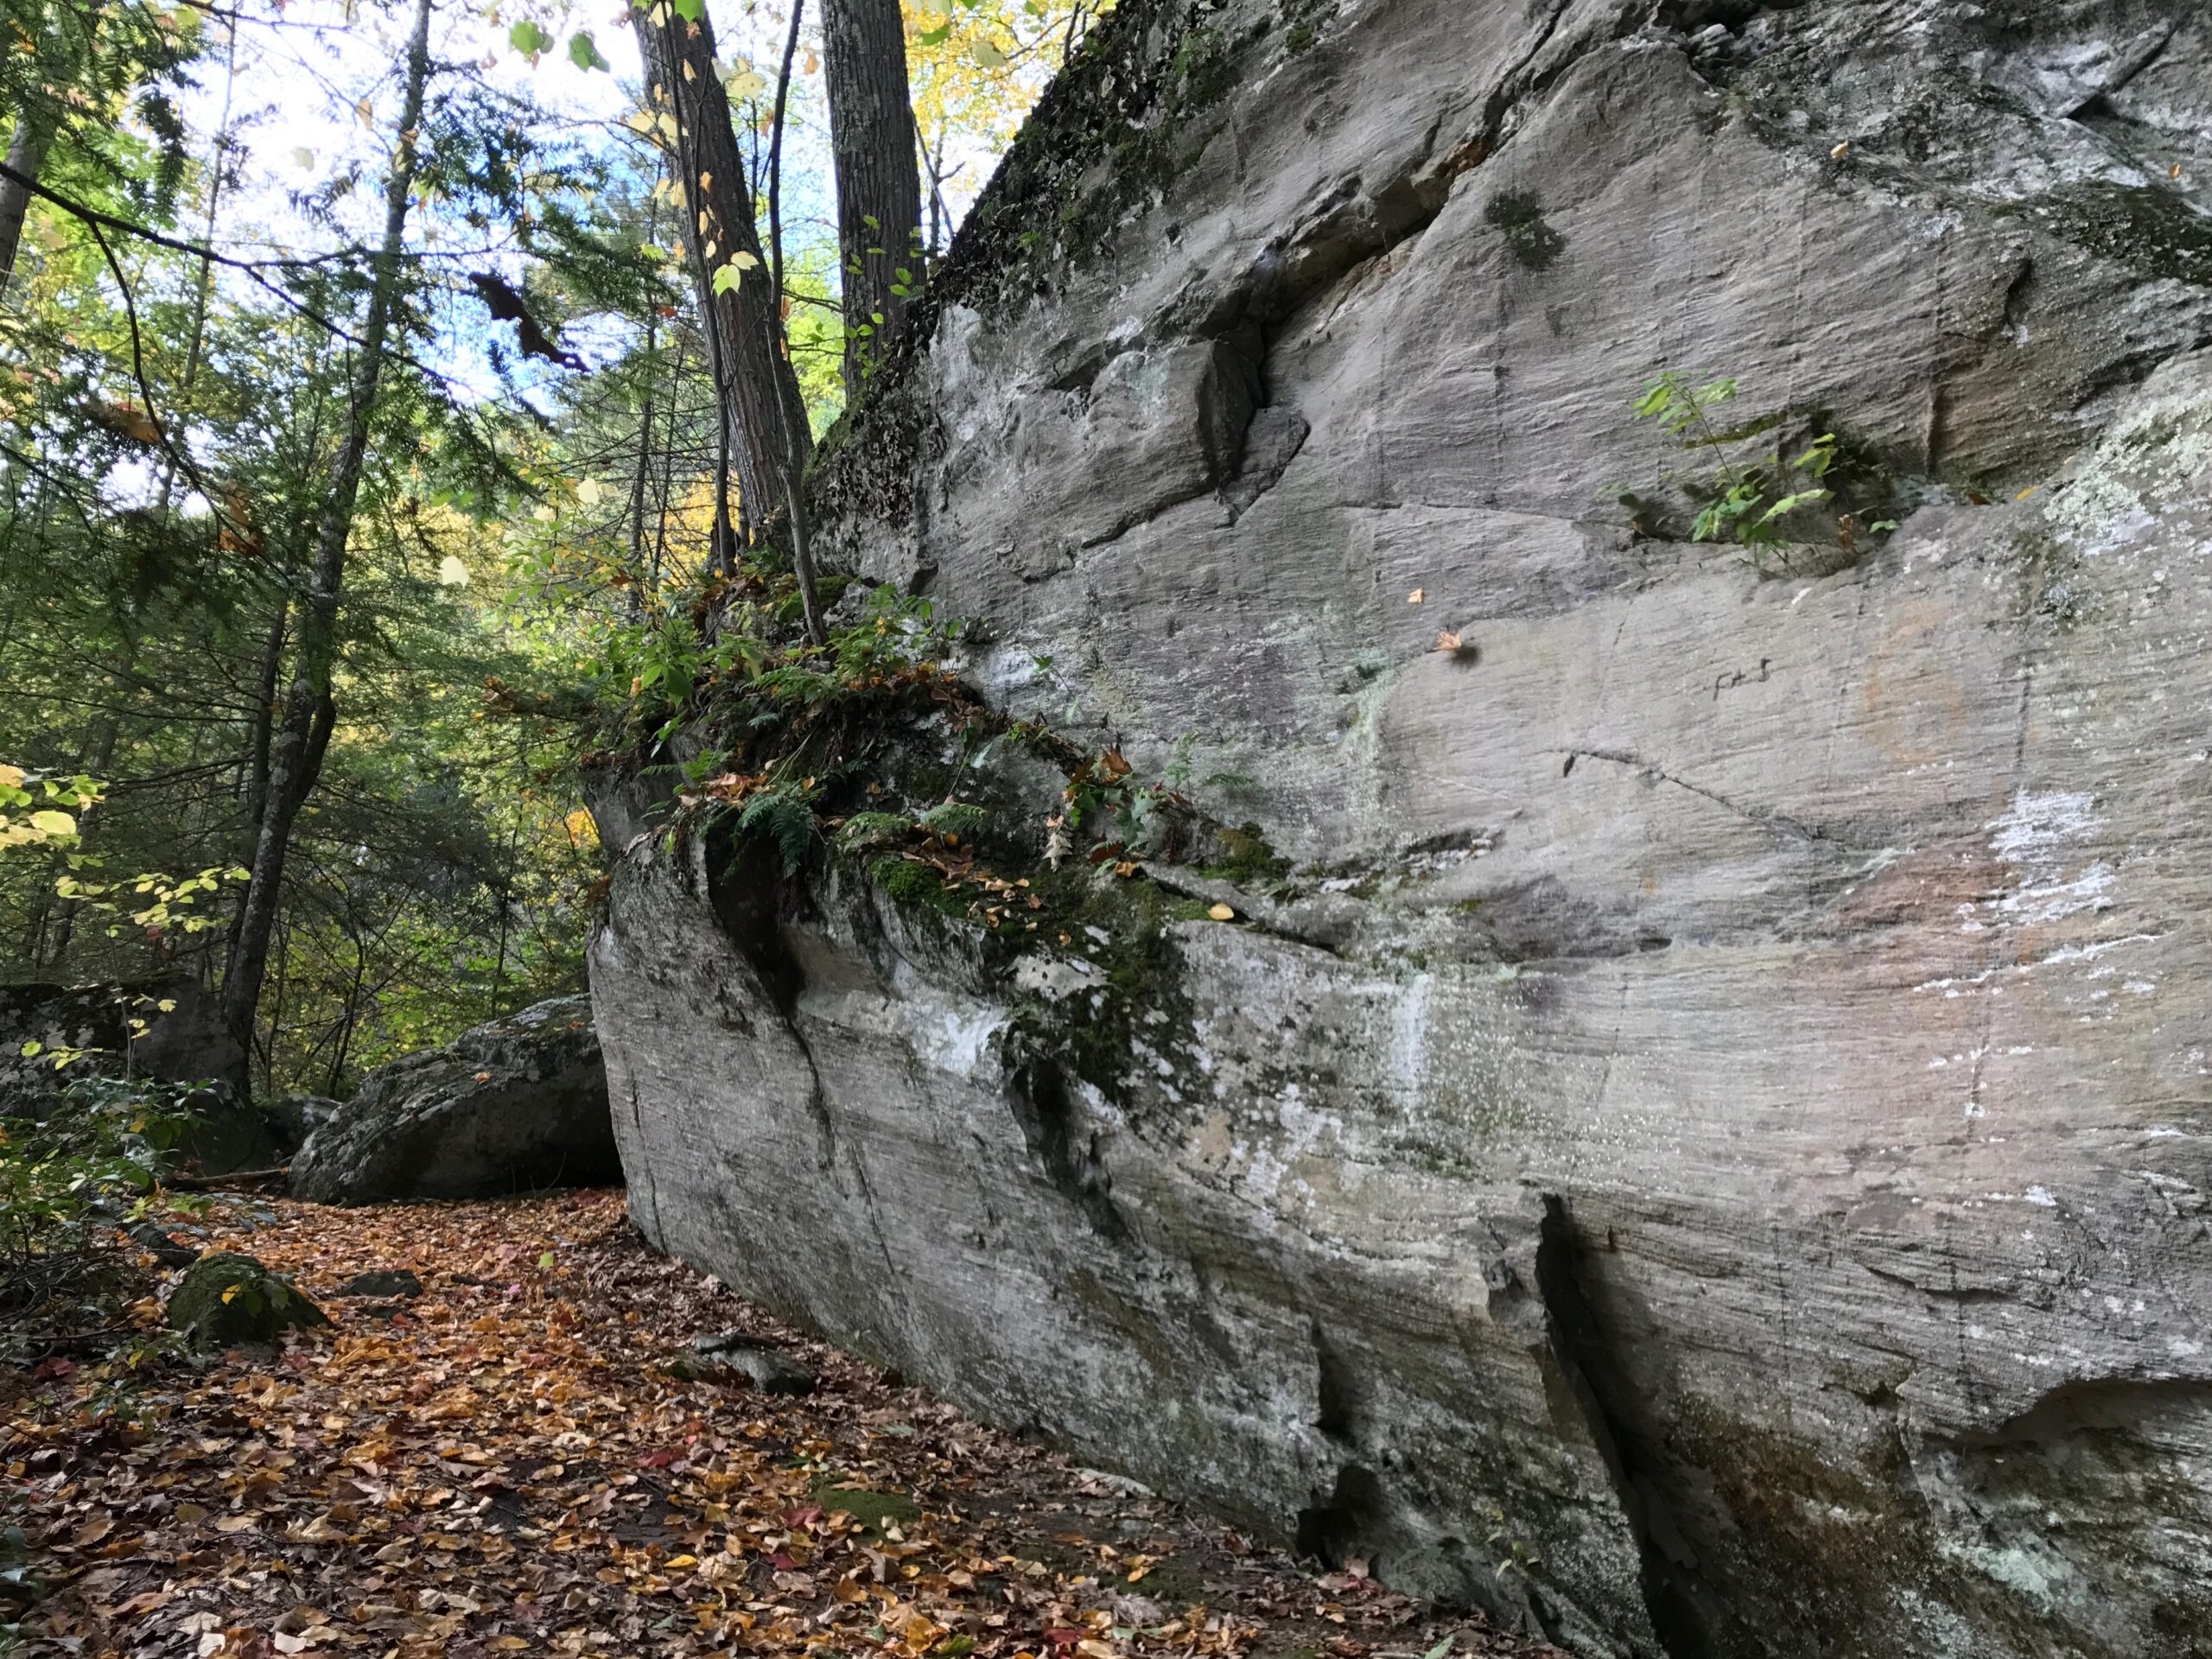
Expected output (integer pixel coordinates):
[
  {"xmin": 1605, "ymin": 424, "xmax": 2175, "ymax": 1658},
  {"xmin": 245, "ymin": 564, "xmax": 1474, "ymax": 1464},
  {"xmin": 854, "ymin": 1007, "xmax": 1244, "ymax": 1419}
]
[{"xmin": 0, "ymin": 0, "xmax": 1103, "ymax": 1095}]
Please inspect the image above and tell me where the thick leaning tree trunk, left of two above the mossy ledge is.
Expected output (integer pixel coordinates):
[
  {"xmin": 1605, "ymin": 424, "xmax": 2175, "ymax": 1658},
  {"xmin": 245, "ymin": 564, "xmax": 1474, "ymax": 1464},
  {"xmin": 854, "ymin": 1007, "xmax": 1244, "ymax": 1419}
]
[{"xmin": 631, "ymin": 7, "xmax": 814, "ymax": 535}]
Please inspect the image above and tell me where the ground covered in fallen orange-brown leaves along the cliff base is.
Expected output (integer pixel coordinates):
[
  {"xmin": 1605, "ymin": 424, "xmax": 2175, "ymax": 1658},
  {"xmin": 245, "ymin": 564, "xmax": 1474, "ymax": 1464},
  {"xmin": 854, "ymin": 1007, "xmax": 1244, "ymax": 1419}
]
[{"xmin": 0, "ymin": 1192, "xmax": 1551, "ymax": 1659}]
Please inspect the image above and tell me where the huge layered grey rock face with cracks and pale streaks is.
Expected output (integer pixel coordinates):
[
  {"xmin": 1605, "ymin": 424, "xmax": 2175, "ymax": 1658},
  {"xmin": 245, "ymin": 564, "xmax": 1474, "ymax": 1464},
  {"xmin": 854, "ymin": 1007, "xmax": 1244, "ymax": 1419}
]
[{"xmin": 593, "ymin": 0, "xmax": 2212, "ymax": 1659}]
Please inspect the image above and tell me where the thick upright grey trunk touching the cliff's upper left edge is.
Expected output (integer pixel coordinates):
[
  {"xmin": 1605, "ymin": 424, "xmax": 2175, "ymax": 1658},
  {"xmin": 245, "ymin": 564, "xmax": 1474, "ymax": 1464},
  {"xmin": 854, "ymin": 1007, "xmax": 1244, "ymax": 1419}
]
[{"xmin": 823, "ymin": 0, "xmax": 923, "ymax": 403}]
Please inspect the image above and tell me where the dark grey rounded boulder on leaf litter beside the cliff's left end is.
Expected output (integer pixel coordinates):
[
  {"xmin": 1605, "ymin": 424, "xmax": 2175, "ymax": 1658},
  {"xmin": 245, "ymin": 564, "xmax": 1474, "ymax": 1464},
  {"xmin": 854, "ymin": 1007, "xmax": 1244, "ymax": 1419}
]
[{"xmin": 292, "ymin": 995, "xmax": 621, "ymax": 1204}]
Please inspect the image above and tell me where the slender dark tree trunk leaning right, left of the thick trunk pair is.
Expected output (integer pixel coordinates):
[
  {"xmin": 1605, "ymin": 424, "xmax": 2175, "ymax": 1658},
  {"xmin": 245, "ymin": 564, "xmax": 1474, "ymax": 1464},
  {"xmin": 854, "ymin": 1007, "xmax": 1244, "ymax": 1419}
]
[{"xmin": 224, "ymin": 0, "xmax": 431, "ymax": 1051}]
